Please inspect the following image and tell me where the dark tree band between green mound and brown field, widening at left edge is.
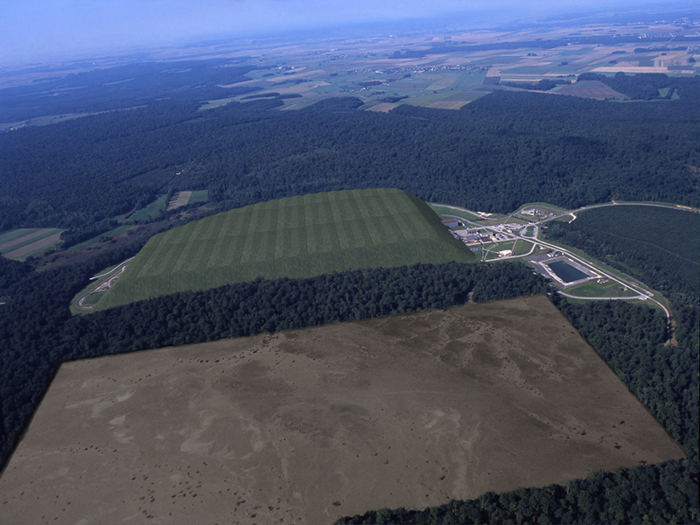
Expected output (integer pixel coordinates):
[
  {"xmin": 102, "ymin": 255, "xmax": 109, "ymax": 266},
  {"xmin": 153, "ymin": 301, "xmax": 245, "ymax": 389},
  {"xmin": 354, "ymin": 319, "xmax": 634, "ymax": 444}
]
[{"xmin": 0, "ymin": 258, "xmax": 547, "ymax": 470}]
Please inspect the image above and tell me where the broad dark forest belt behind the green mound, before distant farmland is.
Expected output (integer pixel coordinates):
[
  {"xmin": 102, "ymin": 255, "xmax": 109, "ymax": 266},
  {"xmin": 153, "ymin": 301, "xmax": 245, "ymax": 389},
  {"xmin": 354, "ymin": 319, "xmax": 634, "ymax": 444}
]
[{"xmin": 0, "ymin": 79, "xmax": 700, "ymax": 231}]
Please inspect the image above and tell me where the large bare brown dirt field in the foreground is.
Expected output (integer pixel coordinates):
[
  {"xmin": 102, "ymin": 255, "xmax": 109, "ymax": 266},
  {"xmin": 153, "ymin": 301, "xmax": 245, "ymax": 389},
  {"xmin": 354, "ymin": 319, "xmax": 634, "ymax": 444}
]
[{"xmin": 0, "ymin": 296, "xmax": 684, "ymax": 525}]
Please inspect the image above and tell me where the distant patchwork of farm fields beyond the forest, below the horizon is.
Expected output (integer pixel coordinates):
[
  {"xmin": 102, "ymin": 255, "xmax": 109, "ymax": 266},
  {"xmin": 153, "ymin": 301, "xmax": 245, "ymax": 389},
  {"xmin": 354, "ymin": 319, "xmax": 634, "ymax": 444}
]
[{"xmin": 189, "ymin": 19, "xmax": 700, "ymax": 112}]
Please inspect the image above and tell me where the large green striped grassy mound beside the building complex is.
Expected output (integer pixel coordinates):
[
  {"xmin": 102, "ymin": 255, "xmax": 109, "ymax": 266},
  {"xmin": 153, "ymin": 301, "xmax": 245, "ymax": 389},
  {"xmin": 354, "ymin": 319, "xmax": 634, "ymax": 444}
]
[{"xmin": 95, "ymin": 189, "xmax": 475, "ymax": 310}]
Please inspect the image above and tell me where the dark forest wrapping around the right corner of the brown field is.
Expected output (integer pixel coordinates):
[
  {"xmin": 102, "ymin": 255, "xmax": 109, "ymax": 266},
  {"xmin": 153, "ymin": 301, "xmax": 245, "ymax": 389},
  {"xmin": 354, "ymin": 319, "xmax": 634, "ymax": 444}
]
[{"xmin": 337, "ymin": 296, "xmax": 698, "ymax": 525}]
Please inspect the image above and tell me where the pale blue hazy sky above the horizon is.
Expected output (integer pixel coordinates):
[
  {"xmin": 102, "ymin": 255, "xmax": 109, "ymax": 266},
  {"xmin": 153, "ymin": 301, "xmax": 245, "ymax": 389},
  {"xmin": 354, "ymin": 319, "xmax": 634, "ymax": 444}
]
[{"xmin": 0, "ymin": 0, "xmax": 688, "ymax": 64}]
